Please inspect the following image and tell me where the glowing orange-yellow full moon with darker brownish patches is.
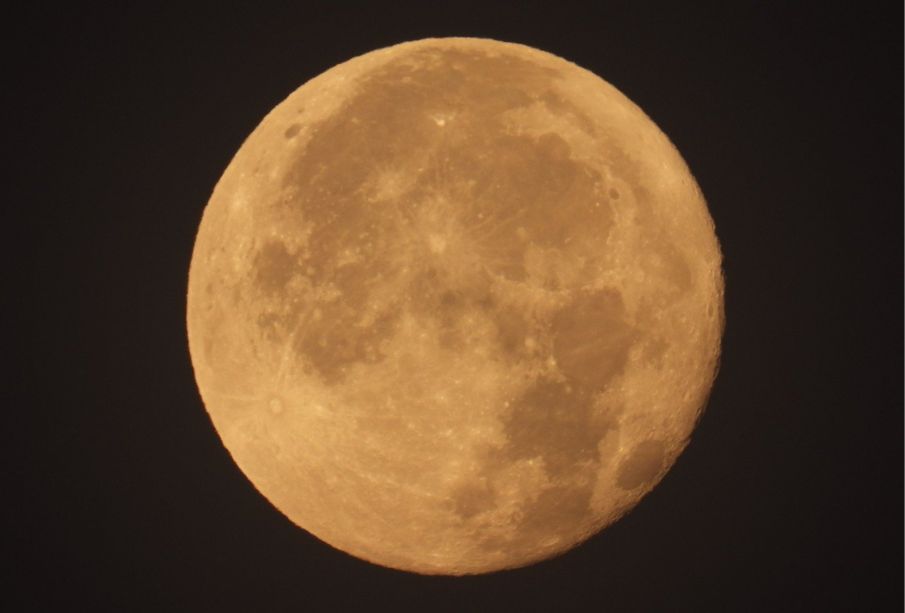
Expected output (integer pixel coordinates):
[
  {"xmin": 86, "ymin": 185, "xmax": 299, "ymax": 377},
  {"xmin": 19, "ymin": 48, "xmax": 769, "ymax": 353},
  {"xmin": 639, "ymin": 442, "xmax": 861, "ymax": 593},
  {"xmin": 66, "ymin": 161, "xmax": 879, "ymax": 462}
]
[{"xmin": 187, "ymin": 38, "xmax": 724, "ymax": 575}]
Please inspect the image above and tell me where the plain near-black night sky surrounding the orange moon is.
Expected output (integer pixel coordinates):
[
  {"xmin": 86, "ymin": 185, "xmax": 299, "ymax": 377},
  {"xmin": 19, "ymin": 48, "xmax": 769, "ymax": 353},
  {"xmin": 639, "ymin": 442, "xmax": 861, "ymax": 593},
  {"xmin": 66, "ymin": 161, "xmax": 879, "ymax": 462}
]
[{"xmin": 12, "ymin": 1, "xmax": 903, "ymax": 611}]
